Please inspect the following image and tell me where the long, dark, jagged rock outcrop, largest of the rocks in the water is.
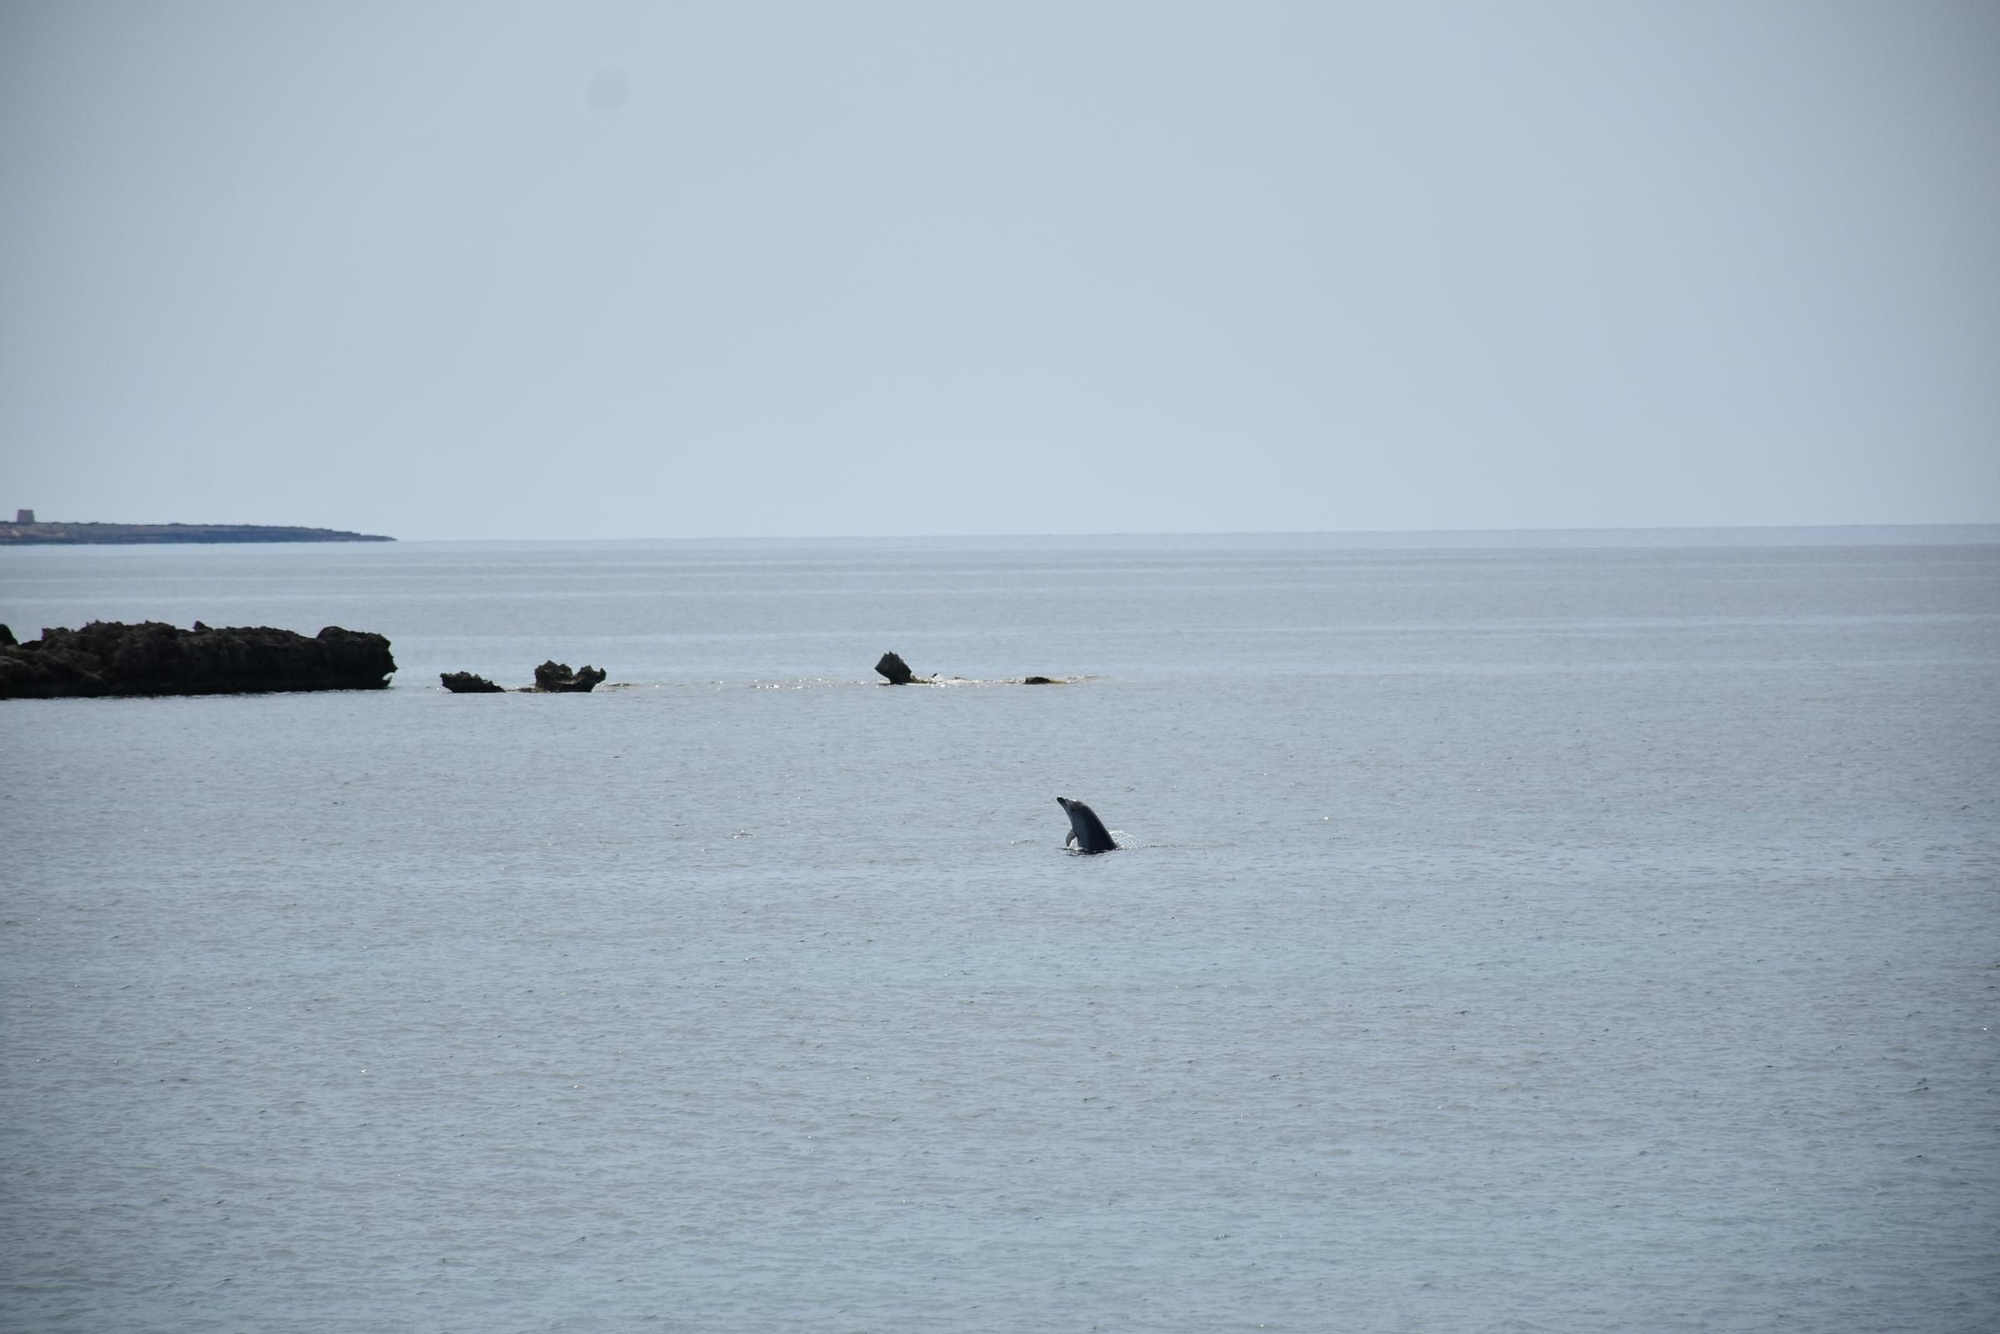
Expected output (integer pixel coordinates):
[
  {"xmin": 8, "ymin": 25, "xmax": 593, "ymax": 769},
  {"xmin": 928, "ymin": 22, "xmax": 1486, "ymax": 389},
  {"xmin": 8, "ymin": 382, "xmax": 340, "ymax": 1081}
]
[{"xmin": 0, "ymin": 620, "xmax": 396, "ymax": 700}]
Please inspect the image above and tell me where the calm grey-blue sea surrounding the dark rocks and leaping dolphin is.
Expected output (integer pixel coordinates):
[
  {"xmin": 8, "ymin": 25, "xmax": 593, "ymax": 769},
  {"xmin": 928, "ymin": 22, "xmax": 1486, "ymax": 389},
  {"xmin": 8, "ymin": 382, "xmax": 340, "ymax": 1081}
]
[{"xmin": 0, "ymin": 528, "xmax": 2000, "ymax": 1334}]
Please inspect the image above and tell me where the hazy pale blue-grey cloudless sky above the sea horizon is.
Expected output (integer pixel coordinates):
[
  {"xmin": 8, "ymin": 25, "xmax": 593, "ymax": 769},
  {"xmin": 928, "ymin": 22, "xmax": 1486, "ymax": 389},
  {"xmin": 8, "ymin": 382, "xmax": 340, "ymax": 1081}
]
[{"xmin": 0, "ymin": 0, "xmax": 2000, "ymax": 538}]
